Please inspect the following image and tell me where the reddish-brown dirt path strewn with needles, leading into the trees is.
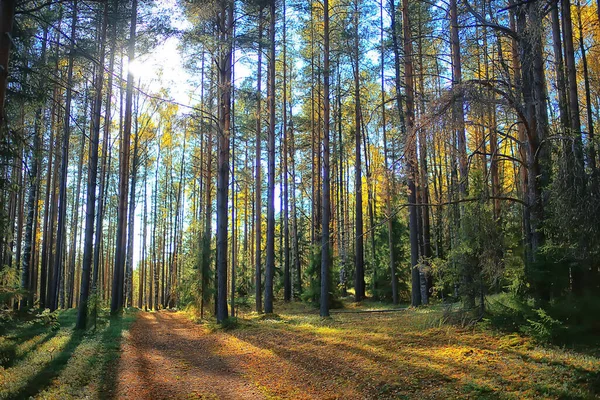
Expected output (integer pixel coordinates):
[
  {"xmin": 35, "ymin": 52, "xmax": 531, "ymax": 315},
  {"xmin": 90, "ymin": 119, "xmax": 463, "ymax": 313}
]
[{"xmin": 116, "ymin": 312, "xmax": 264, "ymax": 400}]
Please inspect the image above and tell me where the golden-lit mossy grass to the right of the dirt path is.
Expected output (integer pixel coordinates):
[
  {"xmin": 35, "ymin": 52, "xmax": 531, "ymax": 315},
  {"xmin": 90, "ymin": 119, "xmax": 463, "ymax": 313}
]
[{"xmin": 192, "ymin": 302, "xmax": 600, "ymax": 399}]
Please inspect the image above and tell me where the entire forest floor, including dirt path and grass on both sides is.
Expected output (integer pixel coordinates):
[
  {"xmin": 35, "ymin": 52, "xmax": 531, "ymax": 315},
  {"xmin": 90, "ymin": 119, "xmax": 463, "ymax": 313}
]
[{"xmin": 0, "ymin": 303, "xmax": 600, "ymax": 400}]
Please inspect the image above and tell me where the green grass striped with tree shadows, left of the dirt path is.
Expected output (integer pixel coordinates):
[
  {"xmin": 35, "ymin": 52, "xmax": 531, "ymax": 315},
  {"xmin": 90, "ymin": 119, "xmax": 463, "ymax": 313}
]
[{"xmin": 0, "ymin": 310, "xmax": 135, "ymax": 399}]
